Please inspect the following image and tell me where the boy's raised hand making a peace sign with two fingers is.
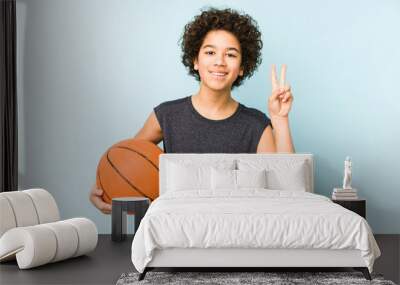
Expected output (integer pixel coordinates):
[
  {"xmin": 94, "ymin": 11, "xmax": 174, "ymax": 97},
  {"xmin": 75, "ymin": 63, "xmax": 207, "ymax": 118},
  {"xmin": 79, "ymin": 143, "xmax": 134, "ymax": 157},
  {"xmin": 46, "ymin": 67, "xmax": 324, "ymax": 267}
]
[{"xmin": 268, "ymin": 64, "xmax": 293, "ymax": 118}]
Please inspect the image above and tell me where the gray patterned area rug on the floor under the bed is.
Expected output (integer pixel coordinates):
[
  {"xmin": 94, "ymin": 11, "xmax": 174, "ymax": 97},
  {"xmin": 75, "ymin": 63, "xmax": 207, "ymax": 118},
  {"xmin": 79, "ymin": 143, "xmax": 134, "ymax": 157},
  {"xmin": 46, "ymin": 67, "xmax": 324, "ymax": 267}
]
[{"xmin": 117, "ymin": 271, "xmax": 395, "ymax": 285}]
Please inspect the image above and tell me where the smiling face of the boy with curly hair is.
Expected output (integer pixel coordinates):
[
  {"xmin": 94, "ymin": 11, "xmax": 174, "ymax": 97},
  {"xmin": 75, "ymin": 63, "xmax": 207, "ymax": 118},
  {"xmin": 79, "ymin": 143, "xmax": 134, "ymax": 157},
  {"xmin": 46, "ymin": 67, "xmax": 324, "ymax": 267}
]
[{"xmin": 194, "ymin": 30, "xmax": 243, "ymax": 90}]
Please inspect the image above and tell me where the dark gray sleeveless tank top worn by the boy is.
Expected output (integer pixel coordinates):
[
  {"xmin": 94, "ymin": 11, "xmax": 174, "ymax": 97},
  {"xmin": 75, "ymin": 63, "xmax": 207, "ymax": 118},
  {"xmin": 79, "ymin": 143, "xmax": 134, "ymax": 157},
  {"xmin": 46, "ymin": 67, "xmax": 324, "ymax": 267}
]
[{"xmin": 154, "ymin": 96, "xmax": 272, "ymax": 153}]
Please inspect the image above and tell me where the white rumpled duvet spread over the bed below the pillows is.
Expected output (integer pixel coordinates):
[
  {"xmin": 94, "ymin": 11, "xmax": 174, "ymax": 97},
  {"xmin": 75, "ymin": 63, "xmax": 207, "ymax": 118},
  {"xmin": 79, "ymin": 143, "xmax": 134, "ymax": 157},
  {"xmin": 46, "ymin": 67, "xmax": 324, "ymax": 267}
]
[{"xmin": 132, "ymin": 189, "xmax": 380, "ymax": 272}]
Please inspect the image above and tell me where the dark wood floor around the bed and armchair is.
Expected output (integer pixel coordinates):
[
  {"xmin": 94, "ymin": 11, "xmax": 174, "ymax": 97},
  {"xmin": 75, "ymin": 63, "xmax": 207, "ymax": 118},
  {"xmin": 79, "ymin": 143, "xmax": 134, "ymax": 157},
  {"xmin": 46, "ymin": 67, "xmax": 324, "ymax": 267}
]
[{"xmin": 0, "ymin": 235, "xmax": 400, "ymax": 285}]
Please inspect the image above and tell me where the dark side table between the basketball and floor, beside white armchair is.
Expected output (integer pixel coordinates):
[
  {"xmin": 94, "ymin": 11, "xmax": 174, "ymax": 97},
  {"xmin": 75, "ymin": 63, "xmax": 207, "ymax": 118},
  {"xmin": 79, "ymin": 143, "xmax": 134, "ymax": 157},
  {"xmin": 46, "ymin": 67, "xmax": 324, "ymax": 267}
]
[{"xmin": 111, "ymin": 197, "xmax": 150, "ymax": 241}]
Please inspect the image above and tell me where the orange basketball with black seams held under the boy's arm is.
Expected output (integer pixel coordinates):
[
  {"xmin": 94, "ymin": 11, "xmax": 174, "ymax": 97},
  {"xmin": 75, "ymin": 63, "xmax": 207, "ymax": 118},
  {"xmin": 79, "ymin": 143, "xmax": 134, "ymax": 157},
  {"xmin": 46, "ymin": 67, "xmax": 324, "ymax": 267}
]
[{"xmin": 96, "ymin": 139, "xmax": 163, "ymax": 203}]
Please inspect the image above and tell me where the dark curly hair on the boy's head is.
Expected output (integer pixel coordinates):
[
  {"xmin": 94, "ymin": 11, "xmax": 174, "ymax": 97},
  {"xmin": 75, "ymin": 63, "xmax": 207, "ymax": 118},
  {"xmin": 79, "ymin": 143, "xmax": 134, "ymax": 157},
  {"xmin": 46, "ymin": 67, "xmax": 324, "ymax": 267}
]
[{"xmin": 180, "ymin": 8, "xmax": 263, "ymax": 88}]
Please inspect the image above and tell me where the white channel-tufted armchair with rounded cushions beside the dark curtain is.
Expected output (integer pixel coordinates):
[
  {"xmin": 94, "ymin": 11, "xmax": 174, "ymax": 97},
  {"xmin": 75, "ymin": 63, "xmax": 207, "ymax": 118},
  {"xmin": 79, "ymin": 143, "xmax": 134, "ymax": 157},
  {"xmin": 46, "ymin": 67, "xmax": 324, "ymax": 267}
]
[{"xmin": 0, "ymin": 188, "xmax": 97, "ymax": 269}]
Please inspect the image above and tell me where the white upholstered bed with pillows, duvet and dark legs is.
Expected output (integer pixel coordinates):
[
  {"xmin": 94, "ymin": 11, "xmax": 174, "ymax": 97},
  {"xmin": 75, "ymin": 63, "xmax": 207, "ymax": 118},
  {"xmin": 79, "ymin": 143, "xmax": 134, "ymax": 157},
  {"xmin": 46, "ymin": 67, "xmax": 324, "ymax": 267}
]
[{"xmin": 131, "ymin": 154, "xmax": 380, "ymax": 280}]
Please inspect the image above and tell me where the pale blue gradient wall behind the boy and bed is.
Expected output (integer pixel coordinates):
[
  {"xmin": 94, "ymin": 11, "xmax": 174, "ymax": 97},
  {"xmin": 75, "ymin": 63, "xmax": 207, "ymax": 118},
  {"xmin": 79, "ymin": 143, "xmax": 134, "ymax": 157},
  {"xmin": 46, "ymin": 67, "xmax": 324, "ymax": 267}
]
[{"xmin": 17, "ymin": 0, "xmax": 400, "ymax": 234}]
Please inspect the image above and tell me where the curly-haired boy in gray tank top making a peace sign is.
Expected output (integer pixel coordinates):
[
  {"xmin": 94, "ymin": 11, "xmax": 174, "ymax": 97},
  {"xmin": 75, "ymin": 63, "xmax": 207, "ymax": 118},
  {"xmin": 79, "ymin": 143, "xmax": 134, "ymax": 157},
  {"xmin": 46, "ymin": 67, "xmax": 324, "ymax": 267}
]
[{"xmin": 90, "ymin": 8, "xmax": 294, "ymax": 214}]
